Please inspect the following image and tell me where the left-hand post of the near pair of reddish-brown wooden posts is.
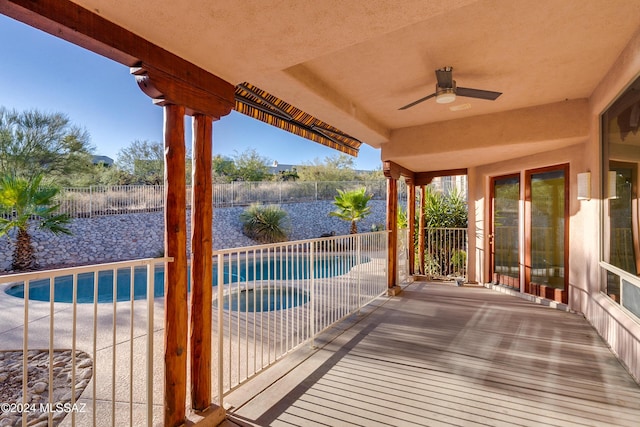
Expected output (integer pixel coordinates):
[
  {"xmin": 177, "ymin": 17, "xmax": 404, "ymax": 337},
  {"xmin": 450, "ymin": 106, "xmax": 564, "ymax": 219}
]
[{"xmin": 164, "ymin": 105, "xmax": 188, "ymax": 427}]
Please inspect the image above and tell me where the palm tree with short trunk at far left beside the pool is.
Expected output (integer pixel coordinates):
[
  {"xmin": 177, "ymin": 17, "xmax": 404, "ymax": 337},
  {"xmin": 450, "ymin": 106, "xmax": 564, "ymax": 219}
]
[{"xmin": 0, "ymin": 175, "xmax": 71, "ymax": 270}]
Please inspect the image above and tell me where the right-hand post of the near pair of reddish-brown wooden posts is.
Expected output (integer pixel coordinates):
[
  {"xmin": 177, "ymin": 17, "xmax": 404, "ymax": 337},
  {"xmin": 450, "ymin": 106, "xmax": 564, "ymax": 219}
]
[{"xmin": 190, "ymin": 114, "xmax": 213, "ymax": 411}]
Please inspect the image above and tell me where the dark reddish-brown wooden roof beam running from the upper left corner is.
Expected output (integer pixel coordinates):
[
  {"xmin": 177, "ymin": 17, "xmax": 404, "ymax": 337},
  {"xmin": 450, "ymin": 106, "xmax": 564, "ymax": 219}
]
[{"xmin": 0, "ymin": 0, "xmax": 235, "ymax": 117}]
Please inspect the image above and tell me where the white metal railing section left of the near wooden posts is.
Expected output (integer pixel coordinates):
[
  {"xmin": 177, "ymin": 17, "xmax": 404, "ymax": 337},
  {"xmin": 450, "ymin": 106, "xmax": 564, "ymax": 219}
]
[{"xmin": 0, "ymin": 258, "xmax": 170, "ymax": 426}]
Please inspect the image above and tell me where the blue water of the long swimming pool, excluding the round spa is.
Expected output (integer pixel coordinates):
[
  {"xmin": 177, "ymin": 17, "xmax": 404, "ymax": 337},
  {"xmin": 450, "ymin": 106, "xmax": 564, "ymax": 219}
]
[{"xmin": 5, "ymin": 255, "xmax": 368, "ymax": 304}]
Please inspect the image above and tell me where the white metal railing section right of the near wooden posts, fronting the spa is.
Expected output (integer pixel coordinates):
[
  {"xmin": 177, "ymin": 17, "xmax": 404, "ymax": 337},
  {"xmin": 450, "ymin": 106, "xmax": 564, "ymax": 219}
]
[{"xmin": 213, "ymin": 232, "xmax": 387, "ymax": 405}]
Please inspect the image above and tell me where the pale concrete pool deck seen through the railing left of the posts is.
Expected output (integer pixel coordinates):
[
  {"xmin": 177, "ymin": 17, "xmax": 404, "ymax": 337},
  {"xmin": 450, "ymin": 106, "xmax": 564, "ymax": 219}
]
[{"xmin": 0, "ymin": 285, "xmax": 164, "ymax": 426}]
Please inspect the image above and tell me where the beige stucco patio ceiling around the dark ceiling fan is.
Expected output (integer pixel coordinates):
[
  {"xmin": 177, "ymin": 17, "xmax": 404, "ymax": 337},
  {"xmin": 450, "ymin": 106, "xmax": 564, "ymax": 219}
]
[{"xmin": 67, "ymin": 0, "xmax": 640, "ymax": 170}]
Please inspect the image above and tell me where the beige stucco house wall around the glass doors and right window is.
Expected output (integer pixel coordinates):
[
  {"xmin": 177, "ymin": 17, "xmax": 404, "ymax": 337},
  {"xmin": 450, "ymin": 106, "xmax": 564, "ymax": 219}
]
[{"xmin": 469, "ymin": 26, "xmax": 640, "ymax": 380}]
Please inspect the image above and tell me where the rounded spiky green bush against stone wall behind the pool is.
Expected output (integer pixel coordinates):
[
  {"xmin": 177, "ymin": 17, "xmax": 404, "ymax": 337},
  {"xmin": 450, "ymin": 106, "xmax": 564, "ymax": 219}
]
[{"xmin": 240, "ymin": 204, "xmax": 289, "ymax": 243}]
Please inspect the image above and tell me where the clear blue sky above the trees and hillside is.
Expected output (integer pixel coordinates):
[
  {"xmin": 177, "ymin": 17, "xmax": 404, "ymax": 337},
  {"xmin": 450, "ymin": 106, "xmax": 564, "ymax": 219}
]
[{"xmin": 0, "ymin": 15, "xmax": 380, "ymax": 170}]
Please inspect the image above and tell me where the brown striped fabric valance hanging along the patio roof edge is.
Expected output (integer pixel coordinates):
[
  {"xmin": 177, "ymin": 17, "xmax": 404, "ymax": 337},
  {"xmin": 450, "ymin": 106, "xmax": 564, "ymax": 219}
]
[{"xmin": 235, "ymin": 83, "xmax": 362, "ymax": 156}]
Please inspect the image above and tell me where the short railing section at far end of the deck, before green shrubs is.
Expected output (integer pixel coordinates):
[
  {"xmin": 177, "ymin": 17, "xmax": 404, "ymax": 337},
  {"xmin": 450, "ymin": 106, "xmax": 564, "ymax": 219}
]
[{"xmin": 424, "ymin": 228, "xmax": 468, "ymax": 279}]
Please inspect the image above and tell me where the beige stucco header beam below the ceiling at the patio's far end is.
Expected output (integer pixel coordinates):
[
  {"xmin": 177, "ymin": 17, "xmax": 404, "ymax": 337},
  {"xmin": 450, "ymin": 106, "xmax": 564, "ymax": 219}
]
[{"xmin": 381, "ymin": 99, "xmax": 589, "ymax": 172}]
